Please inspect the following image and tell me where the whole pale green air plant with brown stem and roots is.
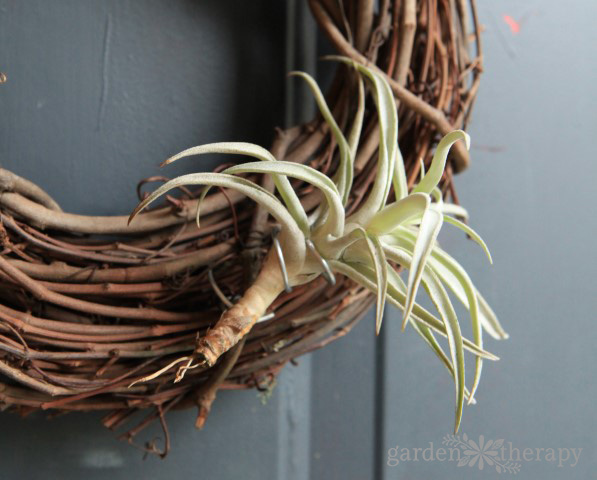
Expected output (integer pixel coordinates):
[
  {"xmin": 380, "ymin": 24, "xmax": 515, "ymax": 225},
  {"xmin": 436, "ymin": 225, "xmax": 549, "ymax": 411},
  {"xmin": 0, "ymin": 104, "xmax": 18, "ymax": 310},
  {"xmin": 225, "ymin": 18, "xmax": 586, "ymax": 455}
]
[{"xmin": 129, "ymin": 57, "xmax": 507, "ymax": 431}]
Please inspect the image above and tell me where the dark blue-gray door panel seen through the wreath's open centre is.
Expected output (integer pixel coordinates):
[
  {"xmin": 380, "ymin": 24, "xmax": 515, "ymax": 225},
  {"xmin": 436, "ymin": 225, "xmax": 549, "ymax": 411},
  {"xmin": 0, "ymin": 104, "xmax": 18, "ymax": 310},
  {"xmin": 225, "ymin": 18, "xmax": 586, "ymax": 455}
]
[{"xmin": 0, "ymin": 0, "xmax": 285, "ymax": 214}]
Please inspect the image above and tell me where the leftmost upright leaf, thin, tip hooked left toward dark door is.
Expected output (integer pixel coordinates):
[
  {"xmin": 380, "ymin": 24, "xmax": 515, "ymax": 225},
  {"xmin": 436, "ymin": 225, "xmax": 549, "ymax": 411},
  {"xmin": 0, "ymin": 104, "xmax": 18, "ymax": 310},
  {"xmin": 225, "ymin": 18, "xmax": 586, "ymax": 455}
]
[{"xmin": 289, "ymin": 72, "xmax": 352, "ymax": 205}]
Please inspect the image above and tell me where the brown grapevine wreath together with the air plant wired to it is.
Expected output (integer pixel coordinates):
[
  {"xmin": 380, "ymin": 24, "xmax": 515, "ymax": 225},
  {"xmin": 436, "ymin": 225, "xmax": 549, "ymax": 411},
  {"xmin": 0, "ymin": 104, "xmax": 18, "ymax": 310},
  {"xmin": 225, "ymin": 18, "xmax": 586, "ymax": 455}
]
[{"xmin": 0, "ymin": 0, "xmax": 507, "ymax": 455}]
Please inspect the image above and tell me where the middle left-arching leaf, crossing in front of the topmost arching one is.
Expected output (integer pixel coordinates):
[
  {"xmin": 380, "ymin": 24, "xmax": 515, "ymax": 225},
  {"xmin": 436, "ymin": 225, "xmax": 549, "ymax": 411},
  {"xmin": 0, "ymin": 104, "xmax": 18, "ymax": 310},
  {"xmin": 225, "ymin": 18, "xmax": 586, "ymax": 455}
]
[{"xmin": 224, "ymin": 162, "xmax": 344, "ymax": 237}]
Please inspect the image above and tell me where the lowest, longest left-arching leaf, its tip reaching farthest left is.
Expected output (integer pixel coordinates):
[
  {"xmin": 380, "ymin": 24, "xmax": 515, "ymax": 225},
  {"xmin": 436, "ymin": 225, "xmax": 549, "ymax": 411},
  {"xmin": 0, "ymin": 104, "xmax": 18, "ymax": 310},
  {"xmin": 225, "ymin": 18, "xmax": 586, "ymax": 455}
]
[{"xmin": 129, "ymin": 173, "xmax": 306, "ymax": 270}]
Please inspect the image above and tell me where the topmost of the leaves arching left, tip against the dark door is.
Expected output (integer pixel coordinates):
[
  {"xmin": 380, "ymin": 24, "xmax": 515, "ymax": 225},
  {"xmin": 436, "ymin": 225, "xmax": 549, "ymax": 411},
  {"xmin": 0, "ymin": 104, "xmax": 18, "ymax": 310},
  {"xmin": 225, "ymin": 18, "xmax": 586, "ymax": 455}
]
[{"xmin": 160, "ymin": 142, "xmax": 309, "ymax": 234}]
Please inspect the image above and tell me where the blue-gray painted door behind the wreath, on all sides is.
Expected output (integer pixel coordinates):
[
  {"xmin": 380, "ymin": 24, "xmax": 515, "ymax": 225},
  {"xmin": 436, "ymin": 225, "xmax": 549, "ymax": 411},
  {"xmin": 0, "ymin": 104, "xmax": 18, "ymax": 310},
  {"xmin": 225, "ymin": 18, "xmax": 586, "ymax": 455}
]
[{"xmin": 0, "ymin": 0, "xmax": 597, "ymax": 480}]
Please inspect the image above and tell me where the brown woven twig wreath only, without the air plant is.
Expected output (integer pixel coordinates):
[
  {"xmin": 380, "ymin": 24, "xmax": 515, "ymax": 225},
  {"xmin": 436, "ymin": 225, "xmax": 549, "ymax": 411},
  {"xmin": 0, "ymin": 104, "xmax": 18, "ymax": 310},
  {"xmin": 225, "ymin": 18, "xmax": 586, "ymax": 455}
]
[{"xmin": 0, "ymin": 0, "xmax": 482, "ymax": 454}]
